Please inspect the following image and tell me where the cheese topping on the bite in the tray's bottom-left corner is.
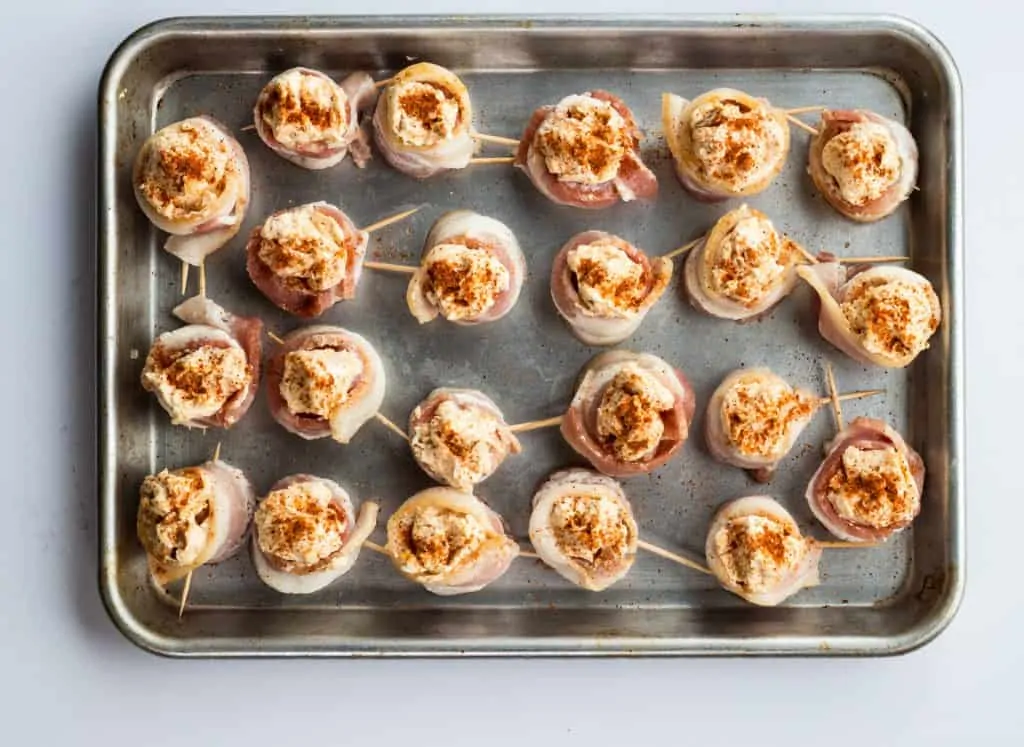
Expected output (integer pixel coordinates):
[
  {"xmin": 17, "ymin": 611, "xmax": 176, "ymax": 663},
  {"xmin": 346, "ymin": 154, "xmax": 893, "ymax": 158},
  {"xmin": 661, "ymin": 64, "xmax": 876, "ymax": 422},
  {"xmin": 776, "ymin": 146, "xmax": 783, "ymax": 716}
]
[{"xmin": 137, "ymin": 467, "xmax": 213, "ymax": 566}]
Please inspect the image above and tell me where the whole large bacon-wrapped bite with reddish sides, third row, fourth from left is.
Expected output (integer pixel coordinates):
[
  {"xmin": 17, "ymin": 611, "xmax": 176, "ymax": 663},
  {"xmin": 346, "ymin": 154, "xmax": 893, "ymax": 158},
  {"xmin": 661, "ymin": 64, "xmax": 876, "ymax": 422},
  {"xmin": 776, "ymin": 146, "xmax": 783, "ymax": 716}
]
[{"xmin": 561, "ymin": 350, "xmax": 696, "ymax": 478}]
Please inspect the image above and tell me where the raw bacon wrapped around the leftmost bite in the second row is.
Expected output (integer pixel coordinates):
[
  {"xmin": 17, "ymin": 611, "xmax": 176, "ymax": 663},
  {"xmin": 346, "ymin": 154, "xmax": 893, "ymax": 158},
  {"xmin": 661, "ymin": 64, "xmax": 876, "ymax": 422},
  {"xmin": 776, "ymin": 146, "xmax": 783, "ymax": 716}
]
[{"xmin": 246, "ymin": 203, "xmax": 370, "ymax": 319}]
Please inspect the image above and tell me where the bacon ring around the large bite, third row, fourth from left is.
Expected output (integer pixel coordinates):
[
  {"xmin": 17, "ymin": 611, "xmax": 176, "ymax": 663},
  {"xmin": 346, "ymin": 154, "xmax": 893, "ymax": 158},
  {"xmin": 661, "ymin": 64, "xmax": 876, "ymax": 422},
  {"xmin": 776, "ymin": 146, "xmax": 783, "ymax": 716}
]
[{"xmin": 561, "ymin": 350, "xmax": 696, "ymax": 478}]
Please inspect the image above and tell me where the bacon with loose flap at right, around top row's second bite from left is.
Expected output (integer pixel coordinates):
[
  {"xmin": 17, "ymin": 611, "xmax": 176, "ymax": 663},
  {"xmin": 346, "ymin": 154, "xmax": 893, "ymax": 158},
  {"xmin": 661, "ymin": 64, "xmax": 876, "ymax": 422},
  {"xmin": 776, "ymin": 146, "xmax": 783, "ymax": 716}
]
[{"xmin": 253, "ymin": 67, "xmax": 377, "ymax": 170}]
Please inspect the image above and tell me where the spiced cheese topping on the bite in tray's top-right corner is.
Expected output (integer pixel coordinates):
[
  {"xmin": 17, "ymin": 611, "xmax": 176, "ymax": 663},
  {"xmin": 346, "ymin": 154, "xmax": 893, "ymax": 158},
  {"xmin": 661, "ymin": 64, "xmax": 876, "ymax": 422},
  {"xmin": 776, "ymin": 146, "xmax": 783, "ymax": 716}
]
[{"xmin": 821, "ymin": 122, "xmax": 903, "ymax": 205}]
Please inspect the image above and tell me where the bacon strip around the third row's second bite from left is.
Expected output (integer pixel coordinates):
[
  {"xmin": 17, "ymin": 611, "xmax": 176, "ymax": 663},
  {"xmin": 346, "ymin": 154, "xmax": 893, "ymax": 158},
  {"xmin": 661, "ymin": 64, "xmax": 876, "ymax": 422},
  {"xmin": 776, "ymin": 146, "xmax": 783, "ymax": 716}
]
[{"xmin": 266, "ymin": 325, "xmax": 387, "ymax": 444}]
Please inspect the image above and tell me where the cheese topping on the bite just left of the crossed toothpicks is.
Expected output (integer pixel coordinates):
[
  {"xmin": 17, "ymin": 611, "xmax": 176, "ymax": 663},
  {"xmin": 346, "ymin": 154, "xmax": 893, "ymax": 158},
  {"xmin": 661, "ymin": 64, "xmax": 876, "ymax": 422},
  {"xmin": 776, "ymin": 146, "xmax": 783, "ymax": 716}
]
[{"xmin": 722, "ymin": 374, "xmax": 816, "ymax": 459}]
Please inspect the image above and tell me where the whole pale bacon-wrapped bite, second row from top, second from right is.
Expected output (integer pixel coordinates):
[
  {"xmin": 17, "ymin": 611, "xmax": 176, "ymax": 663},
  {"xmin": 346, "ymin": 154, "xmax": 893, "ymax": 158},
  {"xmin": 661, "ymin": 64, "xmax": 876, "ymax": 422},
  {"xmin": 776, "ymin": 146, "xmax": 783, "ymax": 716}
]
[{"xmin": 683, "ymin": 205, "xmax": 804, "ymax": 322}]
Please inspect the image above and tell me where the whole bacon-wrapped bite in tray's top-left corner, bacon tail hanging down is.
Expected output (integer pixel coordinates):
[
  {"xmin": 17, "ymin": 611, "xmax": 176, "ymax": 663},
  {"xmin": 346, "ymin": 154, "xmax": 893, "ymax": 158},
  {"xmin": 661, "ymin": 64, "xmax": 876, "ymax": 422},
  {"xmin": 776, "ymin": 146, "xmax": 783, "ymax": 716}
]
[{"xmin": 132, "ymin": 116, "xmax": 250, "ymax": 265}]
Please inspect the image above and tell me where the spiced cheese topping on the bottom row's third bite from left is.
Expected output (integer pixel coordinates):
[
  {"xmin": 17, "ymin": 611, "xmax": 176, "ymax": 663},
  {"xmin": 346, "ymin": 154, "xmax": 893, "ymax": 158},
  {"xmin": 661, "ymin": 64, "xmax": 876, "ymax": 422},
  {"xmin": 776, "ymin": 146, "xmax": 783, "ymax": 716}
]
[{"xmin": 398, "ymin": 506, "xmax": 487, "ymax": 576}]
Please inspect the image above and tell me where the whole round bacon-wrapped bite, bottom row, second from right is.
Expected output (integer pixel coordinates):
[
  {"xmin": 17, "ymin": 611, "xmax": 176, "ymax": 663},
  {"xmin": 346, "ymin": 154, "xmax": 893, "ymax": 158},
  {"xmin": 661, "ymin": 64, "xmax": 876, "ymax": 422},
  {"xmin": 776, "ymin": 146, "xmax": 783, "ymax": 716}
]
[{"xmin": 529, "ymin": 468, "xmax": 639, "ymax": 591}]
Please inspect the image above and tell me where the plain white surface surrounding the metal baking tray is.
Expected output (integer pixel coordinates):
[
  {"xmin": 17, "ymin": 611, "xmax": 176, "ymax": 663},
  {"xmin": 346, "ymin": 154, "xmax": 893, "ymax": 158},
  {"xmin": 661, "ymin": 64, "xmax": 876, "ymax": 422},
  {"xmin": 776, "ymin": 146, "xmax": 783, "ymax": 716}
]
[{"xmin": 0, "ymin": 0, "xmax": 1007, "ymax": 747}]
